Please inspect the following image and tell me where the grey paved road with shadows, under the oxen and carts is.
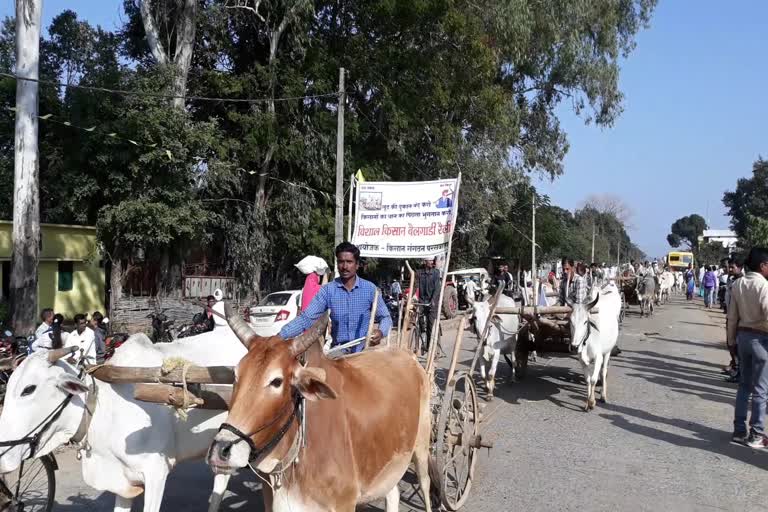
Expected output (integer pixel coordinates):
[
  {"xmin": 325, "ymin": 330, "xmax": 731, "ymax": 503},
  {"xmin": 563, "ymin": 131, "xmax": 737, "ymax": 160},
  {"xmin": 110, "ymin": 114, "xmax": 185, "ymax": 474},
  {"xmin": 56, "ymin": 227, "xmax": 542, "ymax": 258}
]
[{"xmin": 49, "ymin": 299, "xmax": 768, "ymax": 512}]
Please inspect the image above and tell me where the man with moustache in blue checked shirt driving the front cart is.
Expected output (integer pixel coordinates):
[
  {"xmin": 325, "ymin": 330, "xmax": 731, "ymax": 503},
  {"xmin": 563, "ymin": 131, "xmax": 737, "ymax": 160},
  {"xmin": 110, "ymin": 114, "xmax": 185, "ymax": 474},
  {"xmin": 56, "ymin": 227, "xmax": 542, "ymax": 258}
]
[{"xmin": 280, "ymin": 242, "xmax": 392, "ymax": 353}]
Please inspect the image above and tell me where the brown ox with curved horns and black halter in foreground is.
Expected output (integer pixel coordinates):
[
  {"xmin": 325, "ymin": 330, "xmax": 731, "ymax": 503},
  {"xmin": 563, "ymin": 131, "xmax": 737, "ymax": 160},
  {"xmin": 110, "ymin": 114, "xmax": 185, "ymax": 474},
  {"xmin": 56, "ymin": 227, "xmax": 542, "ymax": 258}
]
[{"xmin": 208, "ymin": 311, "xmax": 431, "ymax": 512}]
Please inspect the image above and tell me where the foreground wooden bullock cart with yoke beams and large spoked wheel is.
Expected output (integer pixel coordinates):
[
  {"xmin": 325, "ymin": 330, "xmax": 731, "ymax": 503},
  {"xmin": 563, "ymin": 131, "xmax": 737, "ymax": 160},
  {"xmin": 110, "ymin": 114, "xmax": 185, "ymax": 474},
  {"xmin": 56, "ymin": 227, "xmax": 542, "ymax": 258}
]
[{"xmin": 87, "ymin": 306, "xmax": 493, "ymax": 511}]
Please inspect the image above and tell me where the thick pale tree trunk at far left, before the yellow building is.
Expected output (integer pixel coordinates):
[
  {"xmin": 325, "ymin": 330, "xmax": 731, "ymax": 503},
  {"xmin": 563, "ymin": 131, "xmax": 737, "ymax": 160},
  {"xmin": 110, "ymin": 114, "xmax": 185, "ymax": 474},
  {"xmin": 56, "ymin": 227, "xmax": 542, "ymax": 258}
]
[{"xmin": 10, "ymin": 0, "xmax": 43, "ymax": 335}]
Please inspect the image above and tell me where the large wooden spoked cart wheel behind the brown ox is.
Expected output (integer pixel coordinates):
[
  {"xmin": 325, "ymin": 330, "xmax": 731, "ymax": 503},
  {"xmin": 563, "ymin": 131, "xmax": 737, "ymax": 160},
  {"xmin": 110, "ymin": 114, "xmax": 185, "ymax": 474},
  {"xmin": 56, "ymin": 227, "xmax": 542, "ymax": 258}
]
[{"xmin": 435, "ymin": 372, "xmax": 482, "ymax": 511}]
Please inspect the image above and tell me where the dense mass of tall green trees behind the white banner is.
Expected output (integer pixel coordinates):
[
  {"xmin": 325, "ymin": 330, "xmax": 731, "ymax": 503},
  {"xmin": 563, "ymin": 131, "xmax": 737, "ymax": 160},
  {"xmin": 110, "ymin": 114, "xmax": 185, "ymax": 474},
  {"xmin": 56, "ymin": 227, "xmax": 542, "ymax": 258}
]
[{"xmin": 0, "ymin": 0, "xmax": 656, "ymax": 292}]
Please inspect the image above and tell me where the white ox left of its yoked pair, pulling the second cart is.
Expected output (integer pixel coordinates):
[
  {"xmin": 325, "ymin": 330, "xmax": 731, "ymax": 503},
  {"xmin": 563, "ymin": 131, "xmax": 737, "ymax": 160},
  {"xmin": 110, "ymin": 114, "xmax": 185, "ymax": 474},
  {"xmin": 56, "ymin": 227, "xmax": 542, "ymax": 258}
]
[{"xmin": 472, "ymin": 295, "xmax": 520, "ymax": 396}]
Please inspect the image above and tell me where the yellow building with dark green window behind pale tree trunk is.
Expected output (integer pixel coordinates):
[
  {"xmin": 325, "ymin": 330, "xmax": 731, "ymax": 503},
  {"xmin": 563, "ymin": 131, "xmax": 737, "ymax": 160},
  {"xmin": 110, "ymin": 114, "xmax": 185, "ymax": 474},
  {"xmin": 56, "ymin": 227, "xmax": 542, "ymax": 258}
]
[{"xmin": 0, "ymin": 220, "xmax": 107, "ymax": 319}]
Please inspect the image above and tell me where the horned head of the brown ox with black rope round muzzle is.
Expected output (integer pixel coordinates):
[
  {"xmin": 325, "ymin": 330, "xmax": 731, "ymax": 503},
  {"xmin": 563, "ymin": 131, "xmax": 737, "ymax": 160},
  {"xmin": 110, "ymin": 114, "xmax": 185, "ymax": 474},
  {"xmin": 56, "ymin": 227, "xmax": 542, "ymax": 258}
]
[{"xmin": 207, "ymin": 309, "xmax": 336, "ymax": 474}]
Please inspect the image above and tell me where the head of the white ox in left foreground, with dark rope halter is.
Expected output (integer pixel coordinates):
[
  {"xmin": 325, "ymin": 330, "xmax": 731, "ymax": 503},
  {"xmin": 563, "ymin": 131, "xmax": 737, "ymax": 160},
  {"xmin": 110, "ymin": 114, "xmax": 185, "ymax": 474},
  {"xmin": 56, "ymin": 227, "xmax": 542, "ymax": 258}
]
[{"xmin": 0, "ymin": 349, "xmax": 88, "ymax": 473}]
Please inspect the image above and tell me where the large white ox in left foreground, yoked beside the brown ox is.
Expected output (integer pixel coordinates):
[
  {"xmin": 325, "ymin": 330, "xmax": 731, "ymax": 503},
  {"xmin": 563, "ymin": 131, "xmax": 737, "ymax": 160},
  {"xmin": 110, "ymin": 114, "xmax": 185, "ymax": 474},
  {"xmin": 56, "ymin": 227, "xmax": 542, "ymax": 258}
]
[{"xmin": 0, "ymin": 326, "xmax": 246, "ymax": 512}]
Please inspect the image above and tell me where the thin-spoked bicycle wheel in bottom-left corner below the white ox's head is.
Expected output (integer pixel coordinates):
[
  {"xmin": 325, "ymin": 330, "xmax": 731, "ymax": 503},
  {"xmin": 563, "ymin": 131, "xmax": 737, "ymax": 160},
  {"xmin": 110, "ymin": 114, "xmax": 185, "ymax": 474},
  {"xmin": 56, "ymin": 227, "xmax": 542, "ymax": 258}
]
[{"xmin": 0, "ymin": 456, "xmax": 56, "ymax": 512}]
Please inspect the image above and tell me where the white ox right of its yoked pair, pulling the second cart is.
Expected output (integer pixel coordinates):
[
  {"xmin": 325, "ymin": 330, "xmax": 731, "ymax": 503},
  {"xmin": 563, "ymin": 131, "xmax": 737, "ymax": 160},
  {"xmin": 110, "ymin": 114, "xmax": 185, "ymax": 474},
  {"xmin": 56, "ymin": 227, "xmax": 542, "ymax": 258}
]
[{"xmin": 568, "ymin": 284, "xmax": 621, "ymax": 411}]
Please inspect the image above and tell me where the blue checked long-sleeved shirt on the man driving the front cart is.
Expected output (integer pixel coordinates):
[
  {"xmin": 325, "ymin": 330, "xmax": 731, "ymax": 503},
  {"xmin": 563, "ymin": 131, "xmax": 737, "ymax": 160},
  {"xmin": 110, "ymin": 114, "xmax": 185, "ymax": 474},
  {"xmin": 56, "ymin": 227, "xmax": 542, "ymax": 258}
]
[{"xmin": 280, "ymin": 276, "xmax": 392, "ymax": 352}]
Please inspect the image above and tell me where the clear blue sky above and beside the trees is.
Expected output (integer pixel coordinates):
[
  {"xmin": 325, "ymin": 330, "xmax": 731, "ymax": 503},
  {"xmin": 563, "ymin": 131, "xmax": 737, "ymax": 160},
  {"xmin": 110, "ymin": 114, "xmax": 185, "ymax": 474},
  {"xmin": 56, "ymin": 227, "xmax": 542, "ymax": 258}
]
[{"xmin": 0, "ymin": 0, "xmax": 768, "ymax": 256}]
